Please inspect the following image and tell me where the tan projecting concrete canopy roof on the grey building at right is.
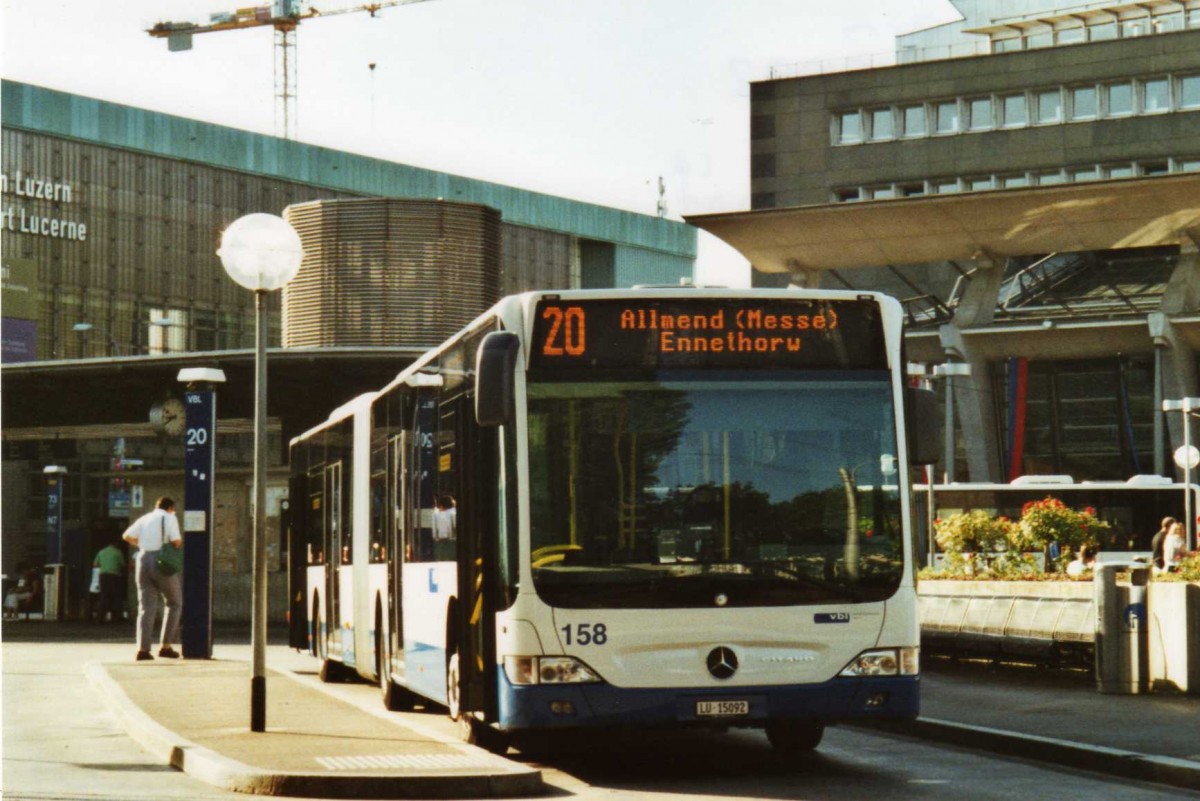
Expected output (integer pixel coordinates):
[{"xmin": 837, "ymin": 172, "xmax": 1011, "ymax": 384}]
[{"xmin": 685, "ymin": 173, "xmax": 1200, "ymax": 272}]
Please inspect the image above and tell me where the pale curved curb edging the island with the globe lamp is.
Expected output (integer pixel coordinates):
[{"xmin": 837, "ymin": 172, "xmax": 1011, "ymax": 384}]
[{"xmin": 84, "ymin": 662, "xmax": 544, "ymax": 799}]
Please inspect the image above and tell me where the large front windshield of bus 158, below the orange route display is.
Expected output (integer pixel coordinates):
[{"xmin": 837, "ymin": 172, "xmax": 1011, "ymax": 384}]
[{"xmin": 528, "ymin": 371, "xmax": 904, "ymax": 608}]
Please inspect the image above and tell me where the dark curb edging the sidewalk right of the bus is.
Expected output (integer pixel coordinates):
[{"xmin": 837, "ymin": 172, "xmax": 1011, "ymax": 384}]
[{"xmin": 864, "ymin": 717, "xmax": 1200, "ymax": 790}]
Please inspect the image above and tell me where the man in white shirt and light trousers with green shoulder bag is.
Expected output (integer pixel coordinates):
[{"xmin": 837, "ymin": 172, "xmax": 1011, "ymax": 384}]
[{"xmin": 121, "ymin": 496, "xmax": 184, "ymax": 662}]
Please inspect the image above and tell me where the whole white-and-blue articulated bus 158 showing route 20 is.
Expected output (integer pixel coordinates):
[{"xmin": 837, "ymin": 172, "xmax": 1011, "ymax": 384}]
[{"xmin": 289, "ymin": 288, "xmax": 938, "ymax": 751}]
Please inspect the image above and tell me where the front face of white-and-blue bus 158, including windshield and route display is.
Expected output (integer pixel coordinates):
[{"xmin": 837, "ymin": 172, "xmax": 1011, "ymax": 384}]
[{"xmin": 497, "ymin": 291, "xmax": 919, "ymax": 749}]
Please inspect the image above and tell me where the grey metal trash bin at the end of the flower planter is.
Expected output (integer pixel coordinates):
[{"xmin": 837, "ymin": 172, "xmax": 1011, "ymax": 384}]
[{"xmin": 1094, "ymin": 565, "xmax": 1150, "ymax": 694}]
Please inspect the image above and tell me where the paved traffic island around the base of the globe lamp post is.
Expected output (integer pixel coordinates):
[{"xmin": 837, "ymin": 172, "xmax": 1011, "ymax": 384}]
[{"xmin": 88, "ymin": 660, "xmax": 542, "ymax": 799}]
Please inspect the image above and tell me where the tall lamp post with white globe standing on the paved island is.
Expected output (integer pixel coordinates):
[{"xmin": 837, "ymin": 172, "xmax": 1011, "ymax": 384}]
[{"xmin": 217, "ymin": 213, "xmax": 304, "ymax": 731}]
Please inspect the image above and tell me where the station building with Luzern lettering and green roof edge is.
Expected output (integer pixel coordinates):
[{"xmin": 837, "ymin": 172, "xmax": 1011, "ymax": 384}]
[{"xmin": 0, "ymin": 82, "xmax": 696, "ymax": 620}]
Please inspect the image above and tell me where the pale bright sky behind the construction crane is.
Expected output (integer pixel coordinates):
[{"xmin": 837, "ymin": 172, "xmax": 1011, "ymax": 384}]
[{"xmin": 0, "ymin": 0, "xmax": 959, "ymax": 287}]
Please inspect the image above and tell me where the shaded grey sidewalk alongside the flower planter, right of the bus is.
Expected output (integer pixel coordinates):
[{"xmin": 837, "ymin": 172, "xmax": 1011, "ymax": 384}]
[{"xmin": 864, "ymin": 661, "xmax": 1200, "ymax": 790}]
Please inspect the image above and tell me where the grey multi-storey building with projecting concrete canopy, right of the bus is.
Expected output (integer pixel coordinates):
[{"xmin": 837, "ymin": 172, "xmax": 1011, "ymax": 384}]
[{"xmin": 689, "ymin": 0, "xmax": 1200, "ymax": 489}]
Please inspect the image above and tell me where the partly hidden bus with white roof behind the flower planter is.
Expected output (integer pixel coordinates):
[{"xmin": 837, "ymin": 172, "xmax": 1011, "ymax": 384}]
[{"xmin": 914, "ymin": 475, "xmax": 1200, "ymax": 562}]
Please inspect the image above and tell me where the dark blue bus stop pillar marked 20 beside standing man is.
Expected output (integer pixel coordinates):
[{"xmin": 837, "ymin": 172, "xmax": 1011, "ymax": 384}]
[{"xmin": 182, "ymin": 385, "xmax": 217, "ymax": 660}]
